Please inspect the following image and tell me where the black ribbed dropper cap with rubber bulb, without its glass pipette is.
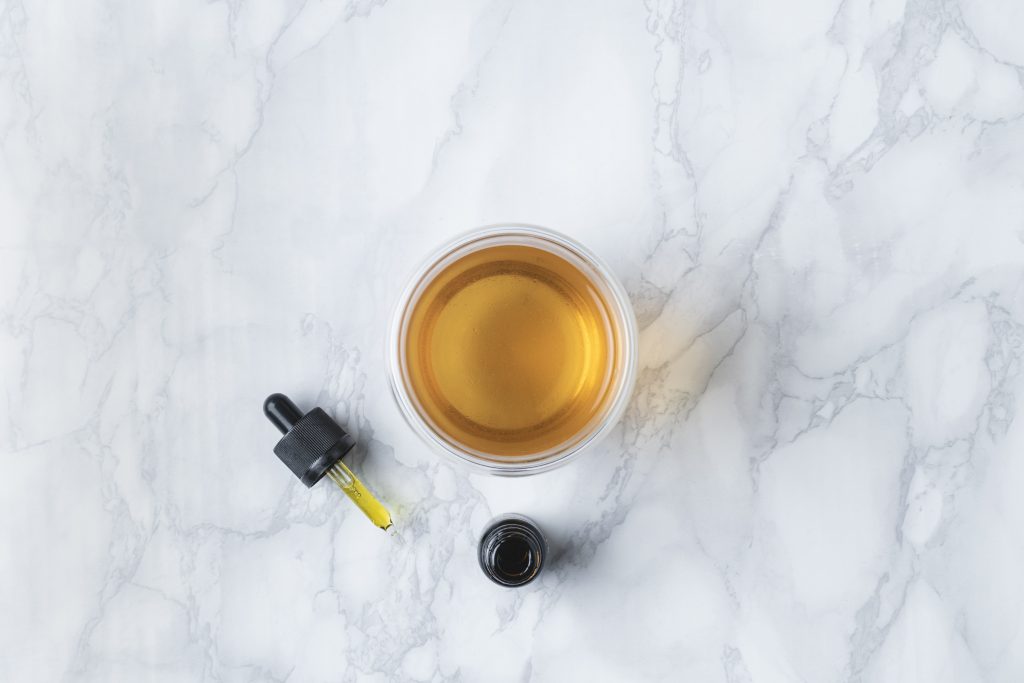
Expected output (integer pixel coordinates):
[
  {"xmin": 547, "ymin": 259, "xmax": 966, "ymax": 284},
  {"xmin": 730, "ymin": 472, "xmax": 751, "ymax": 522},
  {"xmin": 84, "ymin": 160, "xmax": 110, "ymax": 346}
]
[{"xmin": 263, "ymin": 393, "xmax": 355, "ymax": 486}]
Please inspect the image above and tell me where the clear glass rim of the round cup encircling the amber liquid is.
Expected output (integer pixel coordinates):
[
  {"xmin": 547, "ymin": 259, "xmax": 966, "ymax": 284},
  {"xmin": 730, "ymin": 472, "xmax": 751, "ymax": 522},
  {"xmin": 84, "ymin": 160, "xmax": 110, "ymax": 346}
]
[{"xmin": 387, "ymin": 224, "xmax": 637, "ymax": 476}]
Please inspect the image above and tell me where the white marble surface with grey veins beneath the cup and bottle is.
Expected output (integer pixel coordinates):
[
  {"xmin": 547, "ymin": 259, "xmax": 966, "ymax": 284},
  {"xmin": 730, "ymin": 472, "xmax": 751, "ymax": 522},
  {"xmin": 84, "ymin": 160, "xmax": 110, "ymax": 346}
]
[{"xmin": 0, "ymin": 0, "xmax": 1024, "ymax": 683}]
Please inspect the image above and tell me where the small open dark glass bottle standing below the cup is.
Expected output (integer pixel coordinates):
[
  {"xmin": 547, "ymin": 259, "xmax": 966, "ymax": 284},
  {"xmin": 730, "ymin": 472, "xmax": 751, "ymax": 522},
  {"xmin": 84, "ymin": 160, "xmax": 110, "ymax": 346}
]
[{"xmin": 478, "ymin": 515, "xmax": 548, "ymax": 586}]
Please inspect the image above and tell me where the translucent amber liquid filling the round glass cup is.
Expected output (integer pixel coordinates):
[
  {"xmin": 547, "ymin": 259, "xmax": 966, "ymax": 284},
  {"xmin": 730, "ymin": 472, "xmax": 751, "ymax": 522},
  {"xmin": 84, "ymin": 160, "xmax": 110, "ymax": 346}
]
[{"xmin": 406, "ymin": 246, "xmax": 618, "ymax": 456}]
